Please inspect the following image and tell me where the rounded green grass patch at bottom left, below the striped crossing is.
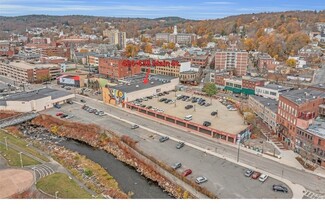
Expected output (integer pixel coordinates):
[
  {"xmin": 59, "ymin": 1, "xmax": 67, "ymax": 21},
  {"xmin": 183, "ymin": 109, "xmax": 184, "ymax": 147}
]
[{"xmin": 36, "ymin": 173, "xmax": 92, "ymax": 199}]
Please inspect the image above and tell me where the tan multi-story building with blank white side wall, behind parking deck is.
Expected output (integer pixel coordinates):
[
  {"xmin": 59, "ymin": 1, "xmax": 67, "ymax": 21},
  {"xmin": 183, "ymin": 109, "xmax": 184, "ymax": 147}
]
[{"xmin": 154, "ymin": 60, "xmax": 191, "ymax": 77}]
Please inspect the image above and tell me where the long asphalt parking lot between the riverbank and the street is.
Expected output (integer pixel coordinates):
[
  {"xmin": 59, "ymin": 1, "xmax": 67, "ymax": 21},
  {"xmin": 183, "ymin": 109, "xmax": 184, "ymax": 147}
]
[{"xmin": 40, "ymin": 103, "xmax": 292, "ymax": 199}]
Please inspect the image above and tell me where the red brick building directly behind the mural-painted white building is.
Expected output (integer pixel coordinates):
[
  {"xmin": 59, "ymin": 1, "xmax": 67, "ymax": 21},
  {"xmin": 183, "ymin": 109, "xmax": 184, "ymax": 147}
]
[{"xmin": 98, "ymin": 58, "xmax": 141, "ymax": 79}]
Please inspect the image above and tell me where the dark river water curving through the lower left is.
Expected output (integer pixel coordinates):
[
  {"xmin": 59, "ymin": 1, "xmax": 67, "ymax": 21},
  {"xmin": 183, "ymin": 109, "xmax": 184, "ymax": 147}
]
[{"xmin": 20, "ymin": 124, "xmax": 172, "ymax": 199}]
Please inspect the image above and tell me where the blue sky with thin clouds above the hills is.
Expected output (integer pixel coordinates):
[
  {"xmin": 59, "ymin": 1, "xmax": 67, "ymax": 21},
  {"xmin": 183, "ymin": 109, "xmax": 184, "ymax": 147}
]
[{"xmin": 0, "ymin": 0, "xmax": 325, "ymax": 19}]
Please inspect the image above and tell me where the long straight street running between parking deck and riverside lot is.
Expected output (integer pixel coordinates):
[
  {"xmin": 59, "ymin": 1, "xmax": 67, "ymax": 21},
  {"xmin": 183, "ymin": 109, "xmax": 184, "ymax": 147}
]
[{"xmin": 66, "ymin": 95, "xmax": 325, "ymax": 194}]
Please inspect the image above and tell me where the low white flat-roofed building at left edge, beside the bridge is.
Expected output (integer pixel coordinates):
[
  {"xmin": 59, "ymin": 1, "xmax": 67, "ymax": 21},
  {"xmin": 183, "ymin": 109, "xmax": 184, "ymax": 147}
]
[{"xmin": 0, "ymin": 88, "xmax": 75, "ymax": 112}]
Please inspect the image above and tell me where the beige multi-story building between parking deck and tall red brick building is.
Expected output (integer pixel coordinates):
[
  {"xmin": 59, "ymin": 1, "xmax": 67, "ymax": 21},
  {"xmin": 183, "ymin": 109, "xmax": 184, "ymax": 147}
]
[{"xmin": 248, "ymin": 95, "xmax": 278, "ymax": 132}]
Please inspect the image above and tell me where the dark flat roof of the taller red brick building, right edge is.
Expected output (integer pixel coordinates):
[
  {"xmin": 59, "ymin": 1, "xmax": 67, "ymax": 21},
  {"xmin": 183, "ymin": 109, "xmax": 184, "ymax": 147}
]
[{"xmin": 281, "ymin": 89, "xmax": 325, "ymax": 105}]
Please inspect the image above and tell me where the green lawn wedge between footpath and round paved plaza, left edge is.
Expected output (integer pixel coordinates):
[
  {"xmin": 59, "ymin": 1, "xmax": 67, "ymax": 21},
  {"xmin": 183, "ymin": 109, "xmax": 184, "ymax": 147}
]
[{"xmin": 0, "ymin": 145, "xmax": 39, "ymax": 167}]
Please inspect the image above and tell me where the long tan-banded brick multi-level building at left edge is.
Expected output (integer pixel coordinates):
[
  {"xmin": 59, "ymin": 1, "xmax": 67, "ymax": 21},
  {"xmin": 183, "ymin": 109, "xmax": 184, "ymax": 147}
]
[{"xmin": 0, "ymin": 62, "xmax": 61, "ymax": 83}]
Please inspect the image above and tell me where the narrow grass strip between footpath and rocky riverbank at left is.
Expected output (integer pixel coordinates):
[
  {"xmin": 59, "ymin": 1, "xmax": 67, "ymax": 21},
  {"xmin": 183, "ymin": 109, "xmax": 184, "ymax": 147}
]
[{"xmin": 0, "ymin": 130, "xmax": 49, "ymax": 162}]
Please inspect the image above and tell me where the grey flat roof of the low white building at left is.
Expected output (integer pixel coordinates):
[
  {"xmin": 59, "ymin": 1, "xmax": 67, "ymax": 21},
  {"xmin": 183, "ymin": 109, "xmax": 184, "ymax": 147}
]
[{"xmin": 0, "ymin": 88, "xmax": 72, "ymax": 104}]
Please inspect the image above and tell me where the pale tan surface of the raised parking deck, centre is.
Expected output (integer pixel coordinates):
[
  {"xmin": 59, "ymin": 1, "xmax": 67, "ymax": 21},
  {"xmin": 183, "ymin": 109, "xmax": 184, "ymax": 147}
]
[{"xmin": 137, "ymin": 92, "xmax": 247, "ymax": 134}]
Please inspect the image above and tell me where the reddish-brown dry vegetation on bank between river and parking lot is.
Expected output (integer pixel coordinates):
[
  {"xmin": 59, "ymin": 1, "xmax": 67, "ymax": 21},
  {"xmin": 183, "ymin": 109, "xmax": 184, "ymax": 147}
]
[{"xmin": 32, "ymin": 115, "xmax": 203, "ymax": 198}]
